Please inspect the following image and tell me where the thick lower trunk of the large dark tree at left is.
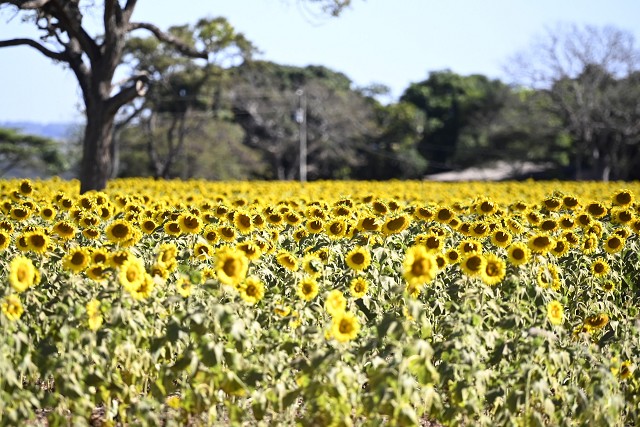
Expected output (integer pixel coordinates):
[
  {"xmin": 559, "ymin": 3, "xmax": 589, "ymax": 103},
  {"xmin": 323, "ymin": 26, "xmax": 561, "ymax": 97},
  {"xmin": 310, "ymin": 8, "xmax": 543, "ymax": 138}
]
[{"xmin": 80, "ymin": 100, "xmax": 115, "ymax": 193}]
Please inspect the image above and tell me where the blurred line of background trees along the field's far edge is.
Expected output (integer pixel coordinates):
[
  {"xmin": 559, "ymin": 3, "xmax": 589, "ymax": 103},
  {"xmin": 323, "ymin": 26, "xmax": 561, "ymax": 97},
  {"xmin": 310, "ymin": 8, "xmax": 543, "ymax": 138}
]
[{"xmin": 0, "ymin": 6, "xmax": 640, "ymax": 182}]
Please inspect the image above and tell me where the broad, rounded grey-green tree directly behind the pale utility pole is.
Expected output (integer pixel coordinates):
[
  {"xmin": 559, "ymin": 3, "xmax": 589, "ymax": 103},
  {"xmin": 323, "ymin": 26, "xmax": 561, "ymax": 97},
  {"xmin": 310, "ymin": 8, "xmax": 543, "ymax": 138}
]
[{"xmin": 226, "ymin": 61, "xmax": 376, "ymax": 179}]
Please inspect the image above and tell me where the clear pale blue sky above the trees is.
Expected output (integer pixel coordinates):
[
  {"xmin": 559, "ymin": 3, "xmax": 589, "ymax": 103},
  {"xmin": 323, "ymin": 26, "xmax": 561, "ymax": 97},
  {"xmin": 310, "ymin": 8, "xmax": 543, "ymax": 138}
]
[{"xmin": 0, "ymin": 0, "xmax": 640, "ymax": 122}]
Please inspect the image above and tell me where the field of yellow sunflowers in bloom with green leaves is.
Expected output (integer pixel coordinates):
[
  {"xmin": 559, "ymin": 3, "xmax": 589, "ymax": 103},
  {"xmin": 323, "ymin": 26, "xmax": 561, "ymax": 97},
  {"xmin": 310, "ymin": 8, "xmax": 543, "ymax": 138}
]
[{"xmin": 0, "ymin": 179, "xmax": 640, "ymax": 426}]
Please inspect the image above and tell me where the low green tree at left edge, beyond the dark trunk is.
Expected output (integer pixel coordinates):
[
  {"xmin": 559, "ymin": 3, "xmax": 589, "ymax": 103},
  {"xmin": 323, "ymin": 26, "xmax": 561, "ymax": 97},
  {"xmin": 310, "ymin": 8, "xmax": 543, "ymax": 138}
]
[{"xmin": 0, "ymin": 128, "xmax": 67, "ymax": 177}]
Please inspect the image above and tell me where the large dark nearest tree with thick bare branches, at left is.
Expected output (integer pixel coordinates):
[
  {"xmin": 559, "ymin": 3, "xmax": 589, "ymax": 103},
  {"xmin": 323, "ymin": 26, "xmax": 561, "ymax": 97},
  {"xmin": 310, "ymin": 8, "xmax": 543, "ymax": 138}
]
[{"xmin": 0, "ymin": 0, "xmax": 350, "ymax": 193}]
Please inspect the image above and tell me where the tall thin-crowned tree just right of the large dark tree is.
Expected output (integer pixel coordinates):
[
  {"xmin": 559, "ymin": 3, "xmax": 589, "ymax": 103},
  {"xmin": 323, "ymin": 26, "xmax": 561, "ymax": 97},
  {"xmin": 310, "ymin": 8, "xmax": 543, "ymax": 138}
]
[{"xmin": 122, "ymin": 17, "xmax": 256, "ymax": 178}]
